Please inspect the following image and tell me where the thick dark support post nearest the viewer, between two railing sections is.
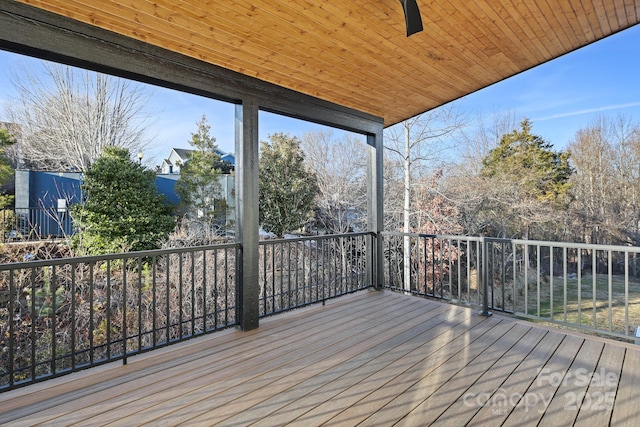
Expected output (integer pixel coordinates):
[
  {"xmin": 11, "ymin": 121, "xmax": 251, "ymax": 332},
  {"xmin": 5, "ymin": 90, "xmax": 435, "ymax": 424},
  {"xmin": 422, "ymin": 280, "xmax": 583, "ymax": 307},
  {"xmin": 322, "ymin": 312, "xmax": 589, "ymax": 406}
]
[{"xmin": 235, "ymin": 99, "xmax": 260, "ymax": 331}]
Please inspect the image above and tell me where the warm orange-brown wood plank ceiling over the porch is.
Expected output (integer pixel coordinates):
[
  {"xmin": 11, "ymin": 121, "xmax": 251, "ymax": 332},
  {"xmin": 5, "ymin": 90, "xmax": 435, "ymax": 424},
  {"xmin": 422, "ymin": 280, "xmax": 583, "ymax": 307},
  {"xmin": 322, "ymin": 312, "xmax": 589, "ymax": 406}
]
[{"xmin": 15, "ymin": 0, "xmax": 640, "ymax": 126}]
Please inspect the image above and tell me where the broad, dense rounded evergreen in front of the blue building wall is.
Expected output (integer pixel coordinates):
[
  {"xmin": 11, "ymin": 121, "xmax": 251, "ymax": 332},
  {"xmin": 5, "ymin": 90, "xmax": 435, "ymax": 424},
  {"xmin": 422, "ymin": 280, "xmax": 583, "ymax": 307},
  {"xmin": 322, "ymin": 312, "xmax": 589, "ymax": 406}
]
[{"xmin": 71, "ymin": 146, "xmax": 175, "ymax": 255}]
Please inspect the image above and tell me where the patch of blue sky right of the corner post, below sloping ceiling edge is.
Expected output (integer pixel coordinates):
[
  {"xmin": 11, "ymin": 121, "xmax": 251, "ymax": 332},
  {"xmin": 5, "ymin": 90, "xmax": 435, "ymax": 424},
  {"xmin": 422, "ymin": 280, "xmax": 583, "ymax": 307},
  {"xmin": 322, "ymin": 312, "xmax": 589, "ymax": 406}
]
[{"xmin": 460, "ymin": 26, "xmax": 640, "ymax": 149}]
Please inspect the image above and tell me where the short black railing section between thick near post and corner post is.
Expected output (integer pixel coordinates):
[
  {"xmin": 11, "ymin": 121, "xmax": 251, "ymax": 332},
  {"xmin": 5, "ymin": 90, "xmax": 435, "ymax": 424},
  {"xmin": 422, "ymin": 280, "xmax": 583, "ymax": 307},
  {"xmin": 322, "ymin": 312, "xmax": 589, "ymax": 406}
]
[{"xmin": 260, "ymin": 233, "xmax": 374, "ymax": 316}]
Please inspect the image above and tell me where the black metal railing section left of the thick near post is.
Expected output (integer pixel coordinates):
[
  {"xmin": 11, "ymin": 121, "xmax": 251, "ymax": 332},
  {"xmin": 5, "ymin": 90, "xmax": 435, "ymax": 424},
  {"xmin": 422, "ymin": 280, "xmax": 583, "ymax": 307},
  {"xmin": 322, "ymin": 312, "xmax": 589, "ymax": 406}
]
[{"xmin": 0, "ymin": 244, "xmax": 239, "ymax": 390}]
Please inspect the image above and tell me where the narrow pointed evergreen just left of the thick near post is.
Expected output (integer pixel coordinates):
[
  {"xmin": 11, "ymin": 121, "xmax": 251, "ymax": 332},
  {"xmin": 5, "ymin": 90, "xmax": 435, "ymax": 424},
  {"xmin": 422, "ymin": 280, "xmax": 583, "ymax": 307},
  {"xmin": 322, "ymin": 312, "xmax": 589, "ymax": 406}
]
[{"xmin": 175, "ymin": 115, "xmax": 231, "ymax": 236}]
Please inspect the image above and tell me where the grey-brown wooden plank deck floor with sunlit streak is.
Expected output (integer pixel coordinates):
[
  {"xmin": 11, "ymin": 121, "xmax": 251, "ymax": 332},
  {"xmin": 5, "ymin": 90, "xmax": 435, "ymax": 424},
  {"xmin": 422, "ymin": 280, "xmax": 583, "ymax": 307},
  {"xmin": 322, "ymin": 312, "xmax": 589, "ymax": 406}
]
[{"xmin": 0, "ymin": 291, "xmax": 640, "ymax": 426}]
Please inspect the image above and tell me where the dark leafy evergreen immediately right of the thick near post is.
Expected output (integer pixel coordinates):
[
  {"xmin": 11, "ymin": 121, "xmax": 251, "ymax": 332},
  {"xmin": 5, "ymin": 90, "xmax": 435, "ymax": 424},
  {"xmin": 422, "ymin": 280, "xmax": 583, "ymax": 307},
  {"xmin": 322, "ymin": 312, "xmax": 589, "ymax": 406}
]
[{"xmin": 258, "ymin": 133, "xmax": 318, "ymax": 236}]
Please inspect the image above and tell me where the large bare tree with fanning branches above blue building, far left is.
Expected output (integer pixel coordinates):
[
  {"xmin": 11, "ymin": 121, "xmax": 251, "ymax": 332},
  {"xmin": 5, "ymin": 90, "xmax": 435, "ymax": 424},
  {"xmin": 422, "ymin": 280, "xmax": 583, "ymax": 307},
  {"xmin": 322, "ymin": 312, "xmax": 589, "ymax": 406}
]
[{"xmin": 8, "ymin": 61, "xmax": 150, "ymax": 171}]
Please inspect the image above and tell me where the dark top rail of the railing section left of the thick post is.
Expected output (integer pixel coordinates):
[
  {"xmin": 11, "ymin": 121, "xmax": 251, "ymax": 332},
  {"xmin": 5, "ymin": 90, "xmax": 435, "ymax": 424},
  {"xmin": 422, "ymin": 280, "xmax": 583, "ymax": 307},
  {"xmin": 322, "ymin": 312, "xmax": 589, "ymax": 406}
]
[{"xmin": 0, "ymin": 243, "xmax": 241, "ymax": 271}]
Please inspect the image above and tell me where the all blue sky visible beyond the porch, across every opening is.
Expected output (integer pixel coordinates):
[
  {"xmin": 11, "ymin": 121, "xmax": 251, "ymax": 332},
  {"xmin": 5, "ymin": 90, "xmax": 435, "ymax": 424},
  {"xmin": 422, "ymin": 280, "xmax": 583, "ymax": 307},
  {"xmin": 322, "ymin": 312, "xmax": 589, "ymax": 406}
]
[{"xmin": 0, "ymin": 26, "xmax": 640, "ymax": 165}]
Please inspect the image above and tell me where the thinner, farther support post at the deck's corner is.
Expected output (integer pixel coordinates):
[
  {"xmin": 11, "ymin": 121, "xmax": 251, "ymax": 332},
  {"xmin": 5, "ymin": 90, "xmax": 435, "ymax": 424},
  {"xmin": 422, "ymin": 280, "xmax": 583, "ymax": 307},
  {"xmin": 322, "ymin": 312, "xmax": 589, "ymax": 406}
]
[{"xmin": 367, "ymin": 130, "xmax": 384, "ymax": 290}]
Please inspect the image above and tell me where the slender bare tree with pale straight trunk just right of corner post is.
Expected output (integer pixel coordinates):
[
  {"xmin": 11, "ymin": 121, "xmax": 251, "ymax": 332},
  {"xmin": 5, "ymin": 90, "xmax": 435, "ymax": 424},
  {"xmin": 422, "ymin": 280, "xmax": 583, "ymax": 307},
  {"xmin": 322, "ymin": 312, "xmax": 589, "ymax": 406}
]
[{"xmin": 385, "ymin": 104, "xmax": 466, "ymax": 290}]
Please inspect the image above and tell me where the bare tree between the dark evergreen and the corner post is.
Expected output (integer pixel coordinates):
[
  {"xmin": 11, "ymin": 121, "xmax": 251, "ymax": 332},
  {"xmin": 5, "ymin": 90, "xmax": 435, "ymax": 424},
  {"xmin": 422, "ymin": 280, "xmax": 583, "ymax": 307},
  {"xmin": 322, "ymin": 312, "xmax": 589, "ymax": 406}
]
[{"xmin": 302, "ymin": 131, "xmax": 367, "ymax": 233}]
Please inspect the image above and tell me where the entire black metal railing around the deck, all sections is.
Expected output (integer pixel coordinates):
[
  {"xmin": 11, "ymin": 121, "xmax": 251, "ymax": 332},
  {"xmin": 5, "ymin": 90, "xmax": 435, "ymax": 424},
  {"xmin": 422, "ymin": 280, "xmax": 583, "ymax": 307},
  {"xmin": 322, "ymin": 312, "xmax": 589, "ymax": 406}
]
[{"xmin": 5, "ymin": 233, "xmax": 640, "ymax": 391}]
